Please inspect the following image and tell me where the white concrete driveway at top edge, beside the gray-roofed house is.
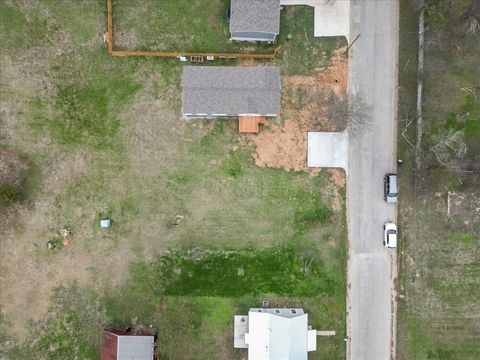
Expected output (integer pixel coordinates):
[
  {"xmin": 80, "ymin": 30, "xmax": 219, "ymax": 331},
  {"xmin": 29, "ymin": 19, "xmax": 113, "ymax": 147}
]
[{"xmin": 280, "ymin": 0, "xmax": 350, "ymax": 42}]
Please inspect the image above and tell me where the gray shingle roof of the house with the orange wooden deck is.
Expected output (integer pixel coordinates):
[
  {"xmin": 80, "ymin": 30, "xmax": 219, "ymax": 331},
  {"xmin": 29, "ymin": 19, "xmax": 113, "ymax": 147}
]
[{"xmin": 182, "ymin": 66, "xmax": 280, "ymax": 115}]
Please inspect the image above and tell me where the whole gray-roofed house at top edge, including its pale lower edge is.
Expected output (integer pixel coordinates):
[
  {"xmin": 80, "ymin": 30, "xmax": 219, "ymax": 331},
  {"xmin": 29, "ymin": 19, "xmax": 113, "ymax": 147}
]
[{"xmin": 230, "ymin": 0, "xmax": 280, "ymax": 42}]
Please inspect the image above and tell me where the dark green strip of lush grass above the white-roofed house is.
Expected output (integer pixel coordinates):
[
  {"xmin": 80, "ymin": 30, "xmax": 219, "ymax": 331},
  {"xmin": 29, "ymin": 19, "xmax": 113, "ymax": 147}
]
[{"xmin": 137, "ymin": 245, "xmax": 342, "ymax": 297}]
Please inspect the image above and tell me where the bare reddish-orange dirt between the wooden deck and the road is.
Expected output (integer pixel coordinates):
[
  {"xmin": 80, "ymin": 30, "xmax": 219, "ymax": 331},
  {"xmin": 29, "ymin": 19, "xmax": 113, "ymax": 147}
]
[{"xmin": 249, "ymin": 48, "xmax": 348, "ymax": 172}]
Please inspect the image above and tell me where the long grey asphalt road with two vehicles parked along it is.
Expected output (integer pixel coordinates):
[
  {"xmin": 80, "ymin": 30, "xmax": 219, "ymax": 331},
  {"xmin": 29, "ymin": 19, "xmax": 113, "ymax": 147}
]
[{"xmin": 347, "ymin": 0, "xmax": 401, "ymax": 360}]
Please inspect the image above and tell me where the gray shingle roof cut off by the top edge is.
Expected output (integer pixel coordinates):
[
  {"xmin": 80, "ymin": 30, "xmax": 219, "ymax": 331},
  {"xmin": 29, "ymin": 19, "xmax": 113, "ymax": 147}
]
[{"xmin": 230, "ymin": 0, "xmax": 280, "ymax": 34}]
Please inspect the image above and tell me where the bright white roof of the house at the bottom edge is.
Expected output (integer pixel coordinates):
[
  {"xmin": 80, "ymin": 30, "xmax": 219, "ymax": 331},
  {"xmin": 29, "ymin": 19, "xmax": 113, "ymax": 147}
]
[{"xmin": 246, "ymin": 311, "xmax": 308, "ymax": 360}]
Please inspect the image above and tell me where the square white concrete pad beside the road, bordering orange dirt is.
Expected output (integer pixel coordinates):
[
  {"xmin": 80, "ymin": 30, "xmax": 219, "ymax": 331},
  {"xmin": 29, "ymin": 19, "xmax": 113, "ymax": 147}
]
[{"xmin": 307, "ymin": 131, "xmax": 348, "ymax": 172}]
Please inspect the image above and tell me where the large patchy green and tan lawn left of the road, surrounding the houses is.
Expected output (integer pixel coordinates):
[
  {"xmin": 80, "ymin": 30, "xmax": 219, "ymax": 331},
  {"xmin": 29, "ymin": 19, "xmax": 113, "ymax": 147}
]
[{"xmin": 0, "ymin": 0, "xmax": 346, "ymax": 359}]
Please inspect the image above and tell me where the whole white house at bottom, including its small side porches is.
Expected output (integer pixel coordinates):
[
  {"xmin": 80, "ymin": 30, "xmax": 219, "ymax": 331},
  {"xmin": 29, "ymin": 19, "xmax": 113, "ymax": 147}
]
[{"xmin": 234, "ymin": 308, "xmax": 317, "ymax": 360}]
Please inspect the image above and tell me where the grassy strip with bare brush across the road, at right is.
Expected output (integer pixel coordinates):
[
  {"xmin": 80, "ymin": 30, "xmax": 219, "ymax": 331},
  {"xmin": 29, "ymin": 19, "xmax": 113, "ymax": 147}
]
[{"xmin": 397, "ymin": 1, "xmax": 480, "ymax": 359}]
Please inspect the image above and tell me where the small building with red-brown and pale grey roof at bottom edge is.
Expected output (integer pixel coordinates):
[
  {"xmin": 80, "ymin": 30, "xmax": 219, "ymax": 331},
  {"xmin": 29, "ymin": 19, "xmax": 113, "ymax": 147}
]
[{"xmin": 100, "ymin": 330, "xmax": 155, "ymax": 360}]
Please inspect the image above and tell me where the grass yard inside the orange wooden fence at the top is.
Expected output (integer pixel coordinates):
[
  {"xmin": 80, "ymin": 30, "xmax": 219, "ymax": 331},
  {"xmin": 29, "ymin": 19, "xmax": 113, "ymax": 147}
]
[{"xmin": 113, "ymin": 0, "xmax": 275, "ymax": 53}]
